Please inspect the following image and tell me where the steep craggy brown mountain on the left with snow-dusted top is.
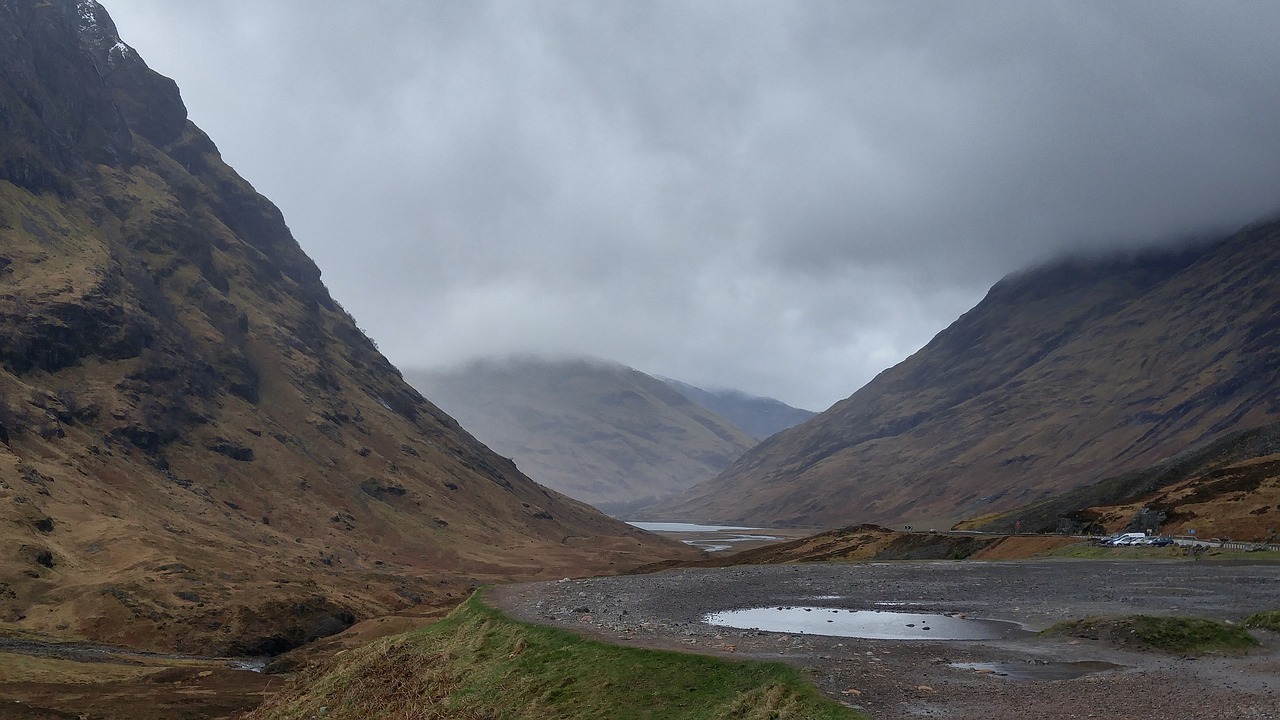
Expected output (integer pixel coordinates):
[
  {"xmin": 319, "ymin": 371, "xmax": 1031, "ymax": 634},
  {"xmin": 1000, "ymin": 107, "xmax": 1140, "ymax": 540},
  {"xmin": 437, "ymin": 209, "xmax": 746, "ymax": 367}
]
[{"xmin": 0, "ymin": 0, "xmax": 682, "ymax": 655}]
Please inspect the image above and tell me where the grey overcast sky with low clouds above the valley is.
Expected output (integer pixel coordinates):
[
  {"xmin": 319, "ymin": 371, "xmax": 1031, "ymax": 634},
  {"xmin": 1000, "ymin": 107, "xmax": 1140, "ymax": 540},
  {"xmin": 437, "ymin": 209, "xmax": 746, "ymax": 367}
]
[{"xmin": 104, "ymin": 0, "xmax": 1280, "ymax": 410}]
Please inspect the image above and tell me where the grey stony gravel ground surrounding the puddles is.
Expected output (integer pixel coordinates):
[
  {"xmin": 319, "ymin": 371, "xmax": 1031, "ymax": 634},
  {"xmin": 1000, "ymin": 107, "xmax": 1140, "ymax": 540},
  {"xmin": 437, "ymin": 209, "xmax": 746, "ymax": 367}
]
[{"xmin": 489, "ymin": 560, "xmax": 1280, "ymax": 720}]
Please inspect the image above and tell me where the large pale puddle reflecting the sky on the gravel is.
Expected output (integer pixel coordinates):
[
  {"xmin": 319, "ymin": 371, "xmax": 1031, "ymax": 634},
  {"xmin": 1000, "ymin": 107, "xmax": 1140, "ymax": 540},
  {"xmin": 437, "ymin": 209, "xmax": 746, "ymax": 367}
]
[{"xmin": 704, "ymin": 606, "xmax": 1030, "ymax": 641}]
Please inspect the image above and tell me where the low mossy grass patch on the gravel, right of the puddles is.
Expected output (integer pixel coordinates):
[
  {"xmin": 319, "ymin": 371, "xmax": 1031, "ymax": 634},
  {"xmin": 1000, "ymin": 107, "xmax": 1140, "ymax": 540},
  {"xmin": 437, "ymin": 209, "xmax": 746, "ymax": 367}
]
[{"xmin": 1043, "ymin": 615, "xmax": 1258, "ymax": 655}]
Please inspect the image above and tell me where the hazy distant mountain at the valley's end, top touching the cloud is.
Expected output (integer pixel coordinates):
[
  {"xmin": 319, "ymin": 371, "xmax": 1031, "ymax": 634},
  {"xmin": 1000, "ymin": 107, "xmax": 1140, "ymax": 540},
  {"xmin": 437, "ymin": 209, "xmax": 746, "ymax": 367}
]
[{"xmin": 406, "ymin": 357, "xmax": 755, "ymax": 514}]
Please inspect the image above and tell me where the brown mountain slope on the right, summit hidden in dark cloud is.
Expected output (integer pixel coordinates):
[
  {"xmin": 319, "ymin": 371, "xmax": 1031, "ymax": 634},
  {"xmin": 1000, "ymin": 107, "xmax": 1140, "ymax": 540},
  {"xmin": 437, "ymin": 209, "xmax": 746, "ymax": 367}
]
[{"xmin": 657, "ymin": 222, "xmax": 1280, "ymax": 527}]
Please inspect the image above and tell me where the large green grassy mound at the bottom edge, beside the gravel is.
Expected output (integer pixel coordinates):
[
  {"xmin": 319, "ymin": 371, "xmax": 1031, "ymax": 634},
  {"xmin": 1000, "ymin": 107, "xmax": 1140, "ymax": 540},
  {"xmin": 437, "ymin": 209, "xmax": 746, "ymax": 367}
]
[{"xmin": 251, "ymin": 596, "xmax": 863, "ymax": 720}]
